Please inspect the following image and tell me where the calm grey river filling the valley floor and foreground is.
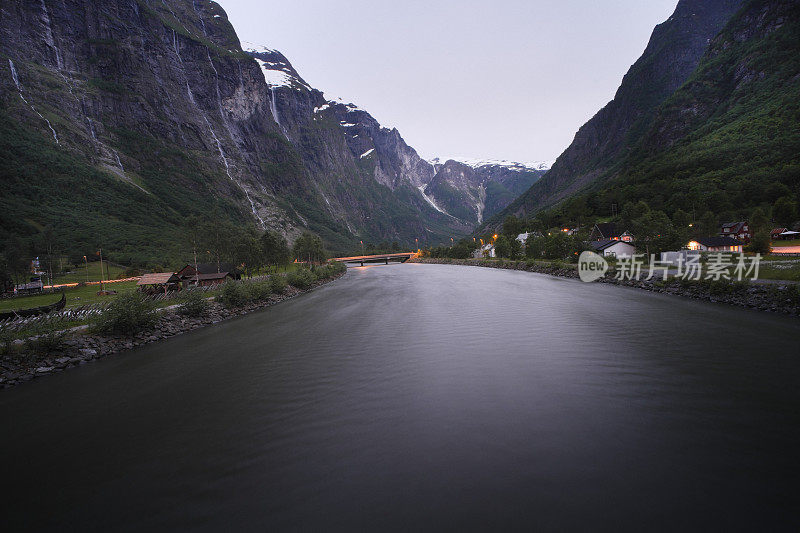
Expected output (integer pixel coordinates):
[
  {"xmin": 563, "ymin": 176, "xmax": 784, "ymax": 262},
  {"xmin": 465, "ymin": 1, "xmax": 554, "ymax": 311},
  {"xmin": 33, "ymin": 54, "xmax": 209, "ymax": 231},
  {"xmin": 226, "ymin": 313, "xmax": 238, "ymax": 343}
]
[{"xmin": 0, "ymin": 264, "xmax": 800, "ymax": 531}]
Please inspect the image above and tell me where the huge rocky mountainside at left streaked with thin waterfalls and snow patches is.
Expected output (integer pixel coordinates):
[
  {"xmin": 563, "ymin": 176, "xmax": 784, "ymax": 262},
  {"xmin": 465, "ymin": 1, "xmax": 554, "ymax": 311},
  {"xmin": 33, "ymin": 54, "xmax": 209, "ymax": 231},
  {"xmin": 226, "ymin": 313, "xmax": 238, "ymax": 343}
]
[{"xmin": 0, "ymin": 0, "xmax": 544, "ymax": 263}]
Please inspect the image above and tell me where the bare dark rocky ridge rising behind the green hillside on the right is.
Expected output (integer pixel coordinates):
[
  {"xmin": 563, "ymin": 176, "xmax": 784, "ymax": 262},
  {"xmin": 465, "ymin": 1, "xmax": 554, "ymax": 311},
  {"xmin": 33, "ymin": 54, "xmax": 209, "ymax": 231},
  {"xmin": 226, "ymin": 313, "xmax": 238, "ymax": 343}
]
[{"xmin": 482, "ymin": 0, "xmax": 743, "ymax": 225}]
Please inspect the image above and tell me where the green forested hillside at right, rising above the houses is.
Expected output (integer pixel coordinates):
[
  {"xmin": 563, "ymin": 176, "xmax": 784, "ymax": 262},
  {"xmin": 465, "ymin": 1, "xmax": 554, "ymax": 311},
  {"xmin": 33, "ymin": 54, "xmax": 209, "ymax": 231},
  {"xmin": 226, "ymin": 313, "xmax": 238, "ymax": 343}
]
[{"xmin": 544, "ymin": 0, "xmax": 800, "ymax": 224}]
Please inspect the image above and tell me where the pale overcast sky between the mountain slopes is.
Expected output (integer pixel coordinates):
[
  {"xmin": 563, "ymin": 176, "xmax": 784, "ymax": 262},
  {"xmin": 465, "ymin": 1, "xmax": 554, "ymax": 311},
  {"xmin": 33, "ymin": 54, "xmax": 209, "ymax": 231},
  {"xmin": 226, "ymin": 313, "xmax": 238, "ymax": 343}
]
[{"xmin": 219, "ymin": 0, "xmax": 677, "ymax": 161}]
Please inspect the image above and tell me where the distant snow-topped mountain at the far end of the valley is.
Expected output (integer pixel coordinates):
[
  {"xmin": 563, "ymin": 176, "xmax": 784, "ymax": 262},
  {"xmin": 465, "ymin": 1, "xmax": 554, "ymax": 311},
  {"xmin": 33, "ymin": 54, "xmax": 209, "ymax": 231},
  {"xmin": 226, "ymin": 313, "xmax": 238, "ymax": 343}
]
[{"xmin": 420, "ymin": 159, "xmax": 550, "ymax": 226}]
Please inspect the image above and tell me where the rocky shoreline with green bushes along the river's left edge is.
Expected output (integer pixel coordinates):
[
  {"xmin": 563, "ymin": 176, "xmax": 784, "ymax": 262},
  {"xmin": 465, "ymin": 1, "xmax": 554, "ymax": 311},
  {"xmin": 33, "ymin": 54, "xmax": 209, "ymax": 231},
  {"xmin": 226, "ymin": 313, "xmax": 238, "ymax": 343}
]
[{"xmin": 0, "ymin": 272, "xmax": 344, "ymax": 388}]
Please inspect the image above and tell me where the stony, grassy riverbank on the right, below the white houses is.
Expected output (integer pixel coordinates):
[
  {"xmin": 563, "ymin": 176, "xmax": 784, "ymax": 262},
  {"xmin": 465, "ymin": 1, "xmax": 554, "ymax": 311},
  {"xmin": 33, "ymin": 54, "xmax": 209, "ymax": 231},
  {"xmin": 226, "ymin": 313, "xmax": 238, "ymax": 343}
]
[{"xmin": 412, "ymin": 258, "xmax": 800, "ymax": 316}]
